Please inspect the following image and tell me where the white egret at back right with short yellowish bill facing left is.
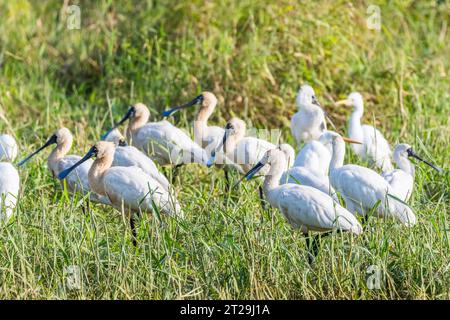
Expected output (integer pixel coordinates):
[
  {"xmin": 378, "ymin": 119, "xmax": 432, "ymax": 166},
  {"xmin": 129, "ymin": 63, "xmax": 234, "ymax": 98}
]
[{"xmin": 336, "ymin": 92, "xmax": 394, "ymax": 172}]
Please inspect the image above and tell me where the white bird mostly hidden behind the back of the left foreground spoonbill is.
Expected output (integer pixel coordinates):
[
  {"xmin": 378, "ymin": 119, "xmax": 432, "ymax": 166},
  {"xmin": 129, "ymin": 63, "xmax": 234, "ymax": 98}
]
[{"xmin": 105, "ymin": 129, "xmax": 170, "ymax": 191}]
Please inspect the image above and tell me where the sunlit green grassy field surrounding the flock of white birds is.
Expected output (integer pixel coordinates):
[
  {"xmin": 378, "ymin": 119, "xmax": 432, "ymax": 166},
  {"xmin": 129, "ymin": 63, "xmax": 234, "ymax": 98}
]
[{"xmin": 0, "ymin": 0, "xmax": 450, "ymax": 299}]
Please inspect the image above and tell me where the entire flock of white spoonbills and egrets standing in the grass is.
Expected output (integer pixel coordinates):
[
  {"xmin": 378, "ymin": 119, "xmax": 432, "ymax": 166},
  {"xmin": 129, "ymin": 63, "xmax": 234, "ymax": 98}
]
[{"xmin": 0, "ymin": 85, "xmax": 441, "ymax": 256}]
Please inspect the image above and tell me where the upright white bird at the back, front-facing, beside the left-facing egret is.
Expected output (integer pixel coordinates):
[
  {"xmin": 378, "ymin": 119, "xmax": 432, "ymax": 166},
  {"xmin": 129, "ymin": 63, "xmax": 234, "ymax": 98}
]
[{"xmin": 291, "ymin": 84, "xmax": 327, "ymax": 145}]
